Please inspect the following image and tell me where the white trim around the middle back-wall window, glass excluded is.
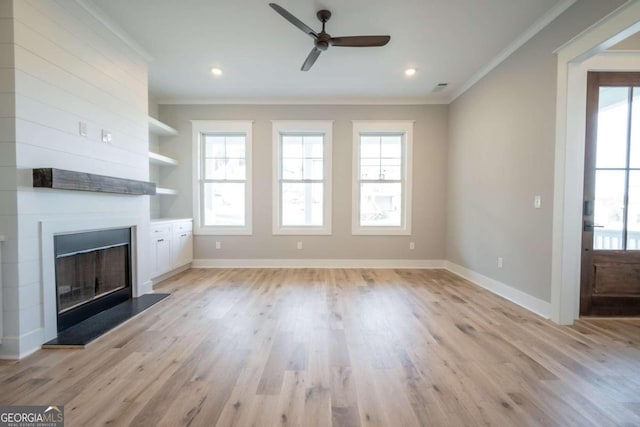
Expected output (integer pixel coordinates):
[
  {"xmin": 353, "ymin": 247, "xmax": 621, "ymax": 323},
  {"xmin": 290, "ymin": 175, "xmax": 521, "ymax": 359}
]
[{"xmin": 271, "ymin": 120, "xmax": 333, "ymax": 236}]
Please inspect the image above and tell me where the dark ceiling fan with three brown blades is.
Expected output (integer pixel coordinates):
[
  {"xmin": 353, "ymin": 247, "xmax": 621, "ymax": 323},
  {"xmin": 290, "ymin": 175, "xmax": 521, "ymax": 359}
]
[{"xmin": 269, "ymin": 3, "xmax": 391, "ymax": 71}]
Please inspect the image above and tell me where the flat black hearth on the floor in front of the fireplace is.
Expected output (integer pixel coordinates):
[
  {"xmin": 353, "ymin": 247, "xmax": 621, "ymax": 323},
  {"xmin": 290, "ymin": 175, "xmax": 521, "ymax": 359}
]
[{"xmin": 42, "ymin": 294, "xmax": 170, "ymax": 348}]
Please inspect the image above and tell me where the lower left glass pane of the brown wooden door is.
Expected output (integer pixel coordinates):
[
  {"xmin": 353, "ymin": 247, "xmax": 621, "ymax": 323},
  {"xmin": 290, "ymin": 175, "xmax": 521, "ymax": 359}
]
[{"xmin": 593, "ymin": 170, "xmax": 625, "ymax": 250}]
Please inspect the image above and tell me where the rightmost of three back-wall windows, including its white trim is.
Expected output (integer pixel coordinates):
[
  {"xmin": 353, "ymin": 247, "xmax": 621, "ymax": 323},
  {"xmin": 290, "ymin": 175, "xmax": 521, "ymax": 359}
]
[{"xmin": 352, "ymin": 121, "xmax": 413, "ymax": 235}]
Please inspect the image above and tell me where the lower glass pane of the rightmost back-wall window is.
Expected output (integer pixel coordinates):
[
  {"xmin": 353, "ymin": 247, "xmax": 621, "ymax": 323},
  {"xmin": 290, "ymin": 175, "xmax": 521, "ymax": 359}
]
[{"xmin": 360, "ymin": 182, "xmax": 402, "ymax": 227}]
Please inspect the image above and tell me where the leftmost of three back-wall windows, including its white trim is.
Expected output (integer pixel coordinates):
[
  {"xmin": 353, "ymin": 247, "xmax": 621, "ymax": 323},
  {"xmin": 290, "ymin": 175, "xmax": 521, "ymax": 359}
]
[{"xmin": 192, "ymin": 120, "xmax": 252, "ymax": 234}]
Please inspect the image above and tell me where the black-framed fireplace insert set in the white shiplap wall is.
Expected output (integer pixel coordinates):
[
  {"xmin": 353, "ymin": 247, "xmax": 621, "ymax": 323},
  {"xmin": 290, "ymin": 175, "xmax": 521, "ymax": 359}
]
[{"xmin": 53, "ymin": 228, "xmax": 132, "ymax": 332}]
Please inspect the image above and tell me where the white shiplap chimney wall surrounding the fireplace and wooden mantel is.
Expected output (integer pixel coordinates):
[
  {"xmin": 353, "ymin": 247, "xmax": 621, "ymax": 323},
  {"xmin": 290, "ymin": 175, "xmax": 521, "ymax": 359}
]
[{"xmin": 0, "ymin": 0, "xmax": 149, "ymax": 357}]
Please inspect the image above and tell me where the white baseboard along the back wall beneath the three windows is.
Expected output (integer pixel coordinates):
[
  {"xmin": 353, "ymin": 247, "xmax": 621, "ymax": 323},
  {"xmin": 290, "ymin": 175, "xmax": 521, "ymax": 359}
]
[{"xmin": 192, "ymin": 259, "xmax": 445, "ymax": 269}]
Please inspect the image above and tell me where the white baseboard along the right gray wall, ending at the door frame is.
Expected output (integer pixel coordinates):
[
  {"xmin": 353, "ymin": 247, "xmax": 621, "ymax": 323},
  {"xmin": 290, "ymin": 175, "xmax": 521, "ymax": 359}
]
[{"xmin": 445, "ymin": 261, "xmax": 551, "ymax": 319}]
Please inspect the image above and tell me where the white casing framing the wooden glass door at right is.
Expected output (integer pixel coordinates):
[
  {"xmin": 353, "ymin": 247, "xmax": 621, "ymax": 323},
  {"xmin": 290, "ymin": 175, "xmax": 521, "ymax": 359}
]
[{"xmin": 551, "ymin": 0, "xmax": 640, "ymax": 324}]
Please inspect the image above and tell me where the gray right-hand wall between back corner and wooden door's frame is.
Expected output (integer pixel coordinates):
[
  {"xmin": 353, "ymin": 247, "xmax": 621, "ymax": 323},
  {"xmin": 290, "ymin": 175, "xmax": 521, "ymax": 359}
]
[{"xmin": 446, "ymin": 0, "xmax": 624, "ymax": 301}]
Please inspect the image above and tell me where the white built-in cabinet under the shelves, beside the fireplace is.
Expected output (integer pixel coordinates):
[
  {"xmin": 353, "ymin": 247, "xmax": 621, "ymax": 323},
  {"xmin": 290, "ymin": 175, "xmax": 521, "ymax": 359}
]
[{"xmin": 150, "ymin": 219, "xmax": 193, "ymax": 278}]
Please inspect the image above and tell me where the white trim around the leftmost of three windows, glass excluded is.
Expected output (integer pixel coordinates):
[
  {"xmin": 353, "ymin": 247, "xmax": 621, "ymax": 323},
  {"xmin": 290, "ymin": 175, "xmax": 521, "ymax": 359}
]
[{"xmin": 191, "ymin": 120, "xmax": 253, "ymax": 235}]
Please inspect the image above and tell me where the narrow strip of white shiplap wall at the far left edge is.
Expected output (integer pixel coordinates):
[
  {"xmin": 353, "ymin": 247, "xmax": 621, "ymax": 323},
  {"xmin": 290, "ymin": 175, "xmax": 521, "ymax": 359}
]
[{"xmin": 0, "ymin": 0, "xmax": 18, "ymax": 352}]
